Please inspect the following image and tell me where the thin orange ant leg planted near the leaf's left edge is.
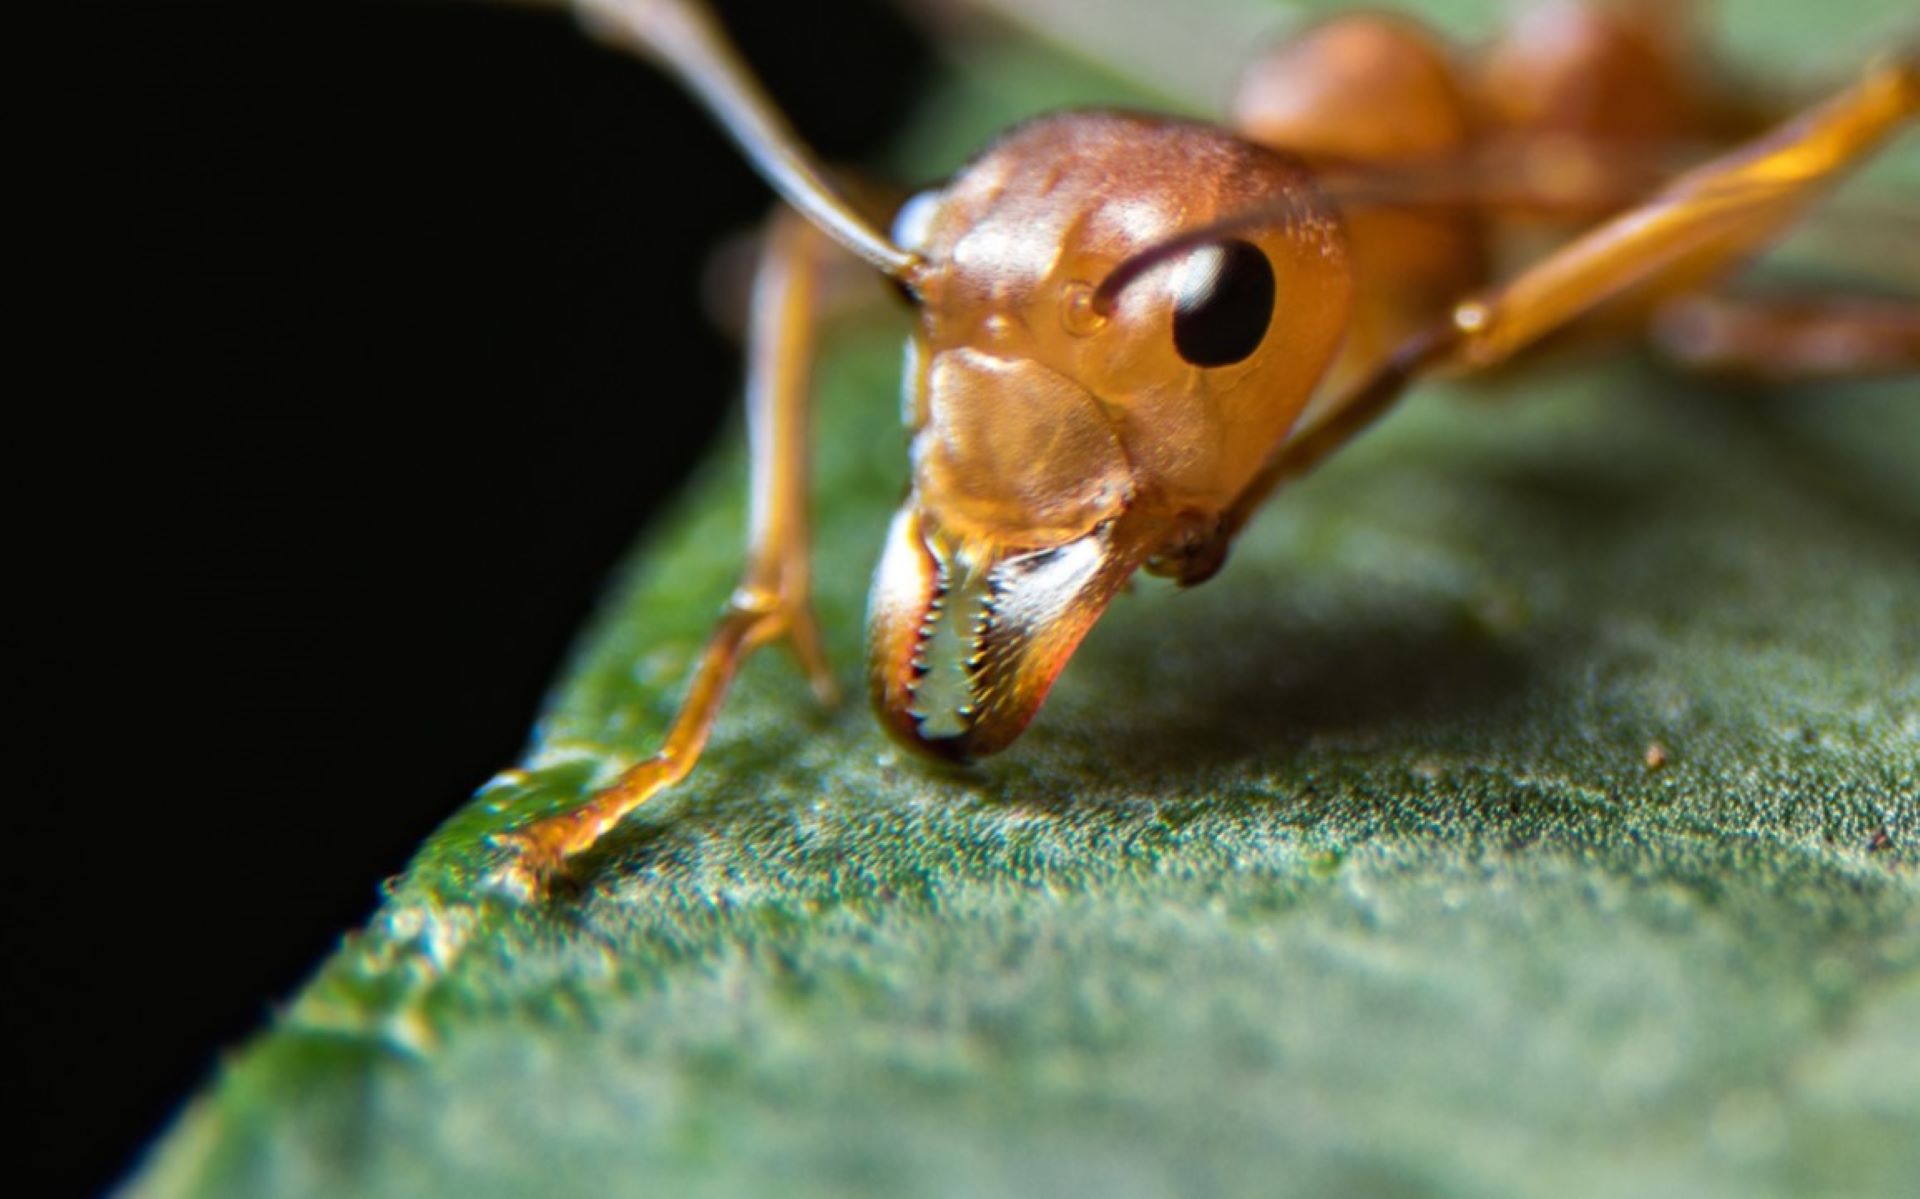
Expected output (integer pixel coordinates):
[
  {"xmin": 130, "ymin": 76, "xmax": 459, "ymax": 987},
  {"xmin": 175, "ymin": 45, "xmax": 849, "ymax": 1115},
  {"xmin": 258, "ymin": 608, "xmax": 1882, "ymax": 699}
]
[{"xmin": 499, "ymin": 208, "xmax": 835, "ymax": 893}]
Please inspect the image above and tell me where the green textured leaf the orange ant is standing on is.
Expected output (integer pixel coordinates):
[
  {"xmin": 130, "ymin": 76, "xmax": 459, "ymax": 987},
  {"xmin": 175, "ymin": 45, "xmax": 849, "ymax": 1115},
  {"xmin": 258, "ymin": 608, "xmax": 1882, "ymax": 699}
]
[{"xmin": 131, "ymin": 0, "xmax": 1920, "ymax": 1197}]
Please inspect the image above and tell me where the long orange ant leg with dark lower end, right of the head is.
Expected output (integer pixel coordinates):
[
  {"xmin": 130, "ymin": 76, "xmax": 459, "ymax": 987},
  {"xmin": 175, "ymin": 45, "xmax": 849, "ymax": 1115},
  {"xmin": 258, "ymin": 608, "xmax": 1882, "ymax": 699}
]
[{"xmin": 1223, "ymin": 56, "xmax": 1920, "ymax": 534}]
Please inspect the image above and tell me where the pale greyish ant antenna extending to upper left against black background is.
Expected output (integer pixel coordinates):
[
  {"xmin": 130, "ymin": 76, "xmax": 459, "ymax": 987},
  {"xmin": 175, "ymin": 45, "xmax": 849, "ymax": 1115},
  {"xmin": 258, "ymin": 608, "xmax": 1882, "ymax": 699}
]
[{"xmin": 572, "ymin": 0, "xmax": 920, "ymax": 284}]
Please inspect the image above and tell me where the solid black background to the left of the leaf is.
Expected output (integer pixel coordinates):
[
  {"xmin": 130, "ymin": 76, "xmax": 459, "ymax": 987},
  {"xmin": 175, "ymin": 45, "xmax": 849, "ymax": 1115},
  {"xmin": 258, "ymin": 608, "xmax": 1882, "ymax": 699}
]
[{"xmin": 56, "ymin": 0, "xmax": 927, "ymax": 1191}]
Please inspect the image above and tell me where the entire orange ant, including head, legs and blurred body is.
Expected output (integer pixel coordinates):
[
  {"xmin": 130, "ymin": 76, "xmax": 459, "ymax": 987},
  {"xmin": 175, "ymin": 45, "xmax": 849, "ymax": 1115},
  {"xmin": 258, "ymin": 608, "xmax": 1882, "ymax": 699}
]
[{"xmin": 487, "ymin": 0, "xmax": 1920, "ymax": 888}]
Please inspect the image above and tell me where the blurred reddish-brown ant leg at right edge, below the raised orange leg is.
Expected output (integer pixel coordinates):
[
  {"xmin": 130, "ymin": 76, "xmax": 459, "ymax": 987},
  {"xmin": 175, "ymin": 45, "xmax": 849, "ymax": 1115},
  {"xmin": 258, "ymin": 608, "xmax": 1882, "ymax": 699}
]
[{"xmin": 1651, "ymin": 296, "xmax": 1920, "ymax": 384}]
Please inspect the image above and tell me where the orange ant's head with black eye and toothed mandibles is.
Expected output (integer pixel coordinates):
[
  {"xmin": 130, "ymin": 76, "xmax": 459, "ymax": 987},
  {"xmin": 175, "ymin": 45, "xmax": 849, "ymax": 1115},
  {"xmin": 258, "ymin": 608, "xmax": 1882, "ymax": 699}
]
[{"xmin": 870, "ymin": 113, "xmax": 1352, "ymax": 759}]
